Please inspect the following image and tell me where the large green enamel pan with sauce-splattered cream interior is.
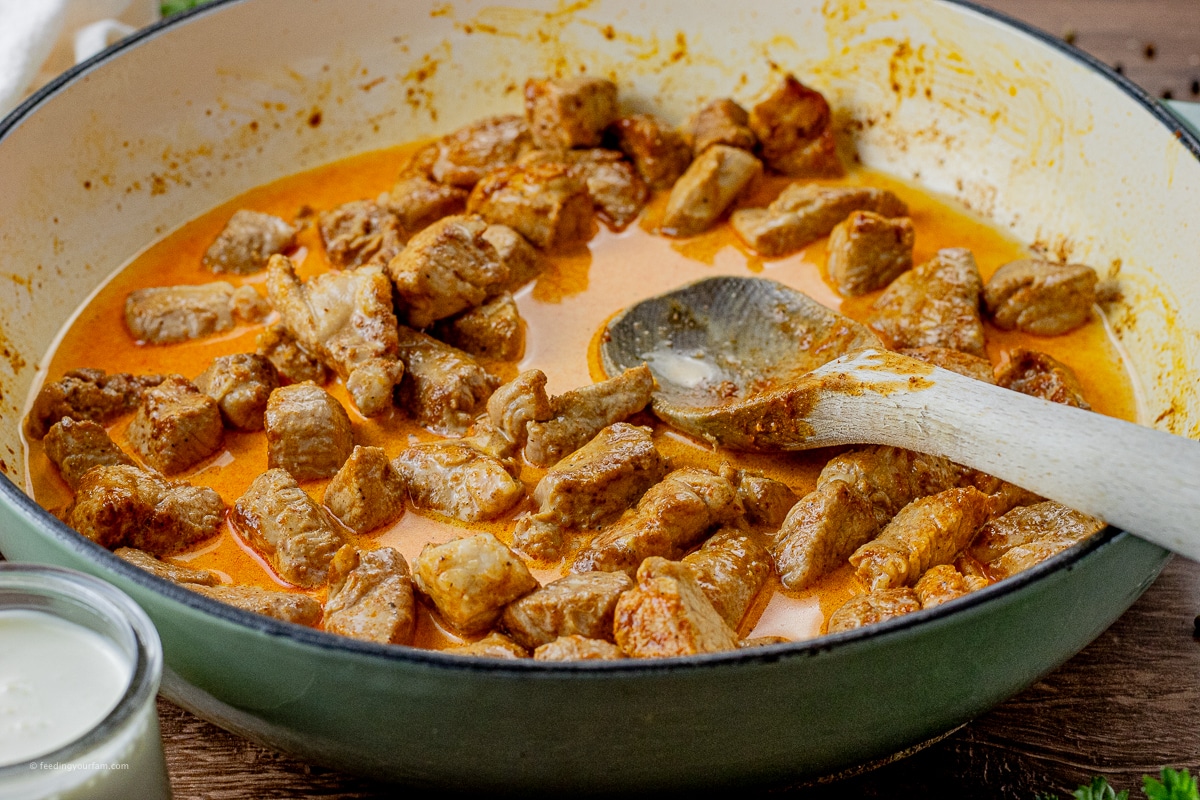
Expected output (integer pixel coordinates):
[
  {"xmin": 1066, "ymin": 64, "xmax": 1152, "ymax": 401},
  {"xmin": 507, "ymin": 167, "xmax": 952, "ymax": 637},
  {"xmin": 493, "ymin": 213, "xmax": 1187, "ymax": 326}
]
[{"xmin": 0, "ymin": 0, "xmax": 1200, "ymax": 793}]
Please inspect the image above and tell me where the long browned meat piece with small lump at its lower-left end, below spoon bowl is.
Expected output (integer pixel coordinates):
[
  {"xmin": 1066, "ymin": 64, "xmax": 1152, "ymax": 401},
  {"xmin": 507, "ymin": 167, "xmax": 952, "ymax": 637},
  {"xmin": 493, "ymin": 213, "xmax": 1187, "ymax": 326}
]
[{"xmin": 512, "ymin": 422, "xmax": 667, "ymax": 559}]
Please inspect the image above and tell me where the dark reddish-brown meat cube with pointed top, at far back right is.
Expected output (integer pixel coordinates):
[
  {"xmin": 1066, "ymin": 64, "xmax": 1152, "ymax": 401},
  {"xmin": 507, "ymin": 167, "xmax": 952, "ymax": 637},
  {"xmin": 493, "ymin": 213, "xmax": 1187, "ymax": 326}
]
[{"xmin": 749, "ymin": 74, "xmax": 844, "ymax": 178}]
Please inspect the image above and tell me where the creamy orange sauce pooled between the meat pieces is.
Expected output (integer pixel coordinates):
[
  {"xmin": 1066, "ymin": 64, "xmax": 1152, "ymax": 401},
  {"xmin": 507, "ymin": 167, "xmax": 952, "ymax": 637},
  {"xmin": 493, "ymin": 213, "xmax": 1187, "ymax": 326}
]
[{"xmin": 26, "ymin": 145, "xmax": 1136, "ymax": 648}]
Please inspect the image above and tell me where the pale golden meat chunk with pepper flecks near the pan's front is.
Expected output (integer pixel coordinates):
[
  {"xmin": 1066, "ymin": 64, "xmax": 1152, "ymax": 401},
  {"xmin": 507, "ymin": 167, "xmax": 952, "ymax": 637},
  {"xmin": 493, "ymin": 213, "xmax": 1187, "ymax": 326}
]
[{"xmin": 413, "ymin": 534, "xmax": 538, "ymax": 636}]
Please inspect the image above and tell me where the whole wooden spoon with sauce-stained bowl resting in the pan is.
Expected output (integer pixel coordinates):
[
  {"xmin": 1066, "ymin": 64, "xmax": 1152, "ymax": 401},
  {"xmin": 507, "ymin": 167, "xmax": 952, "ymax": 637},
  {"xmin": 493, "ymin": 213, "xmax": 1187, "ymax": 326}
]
[{"xmin": 600, "ymin": 277, "xmax": 1200, "ymax": 560}]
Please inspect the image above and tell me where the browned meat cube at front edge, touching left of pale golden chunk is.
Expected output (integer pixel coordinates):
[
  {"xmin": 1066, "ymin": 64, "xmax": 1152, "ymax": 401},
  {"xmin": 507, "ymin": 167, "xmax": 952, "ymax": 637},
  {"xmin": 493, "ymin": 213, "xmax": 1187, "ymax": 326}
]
[{"xmin": 324, "ymin": 545, "xmax": 416, "ymax": 644}]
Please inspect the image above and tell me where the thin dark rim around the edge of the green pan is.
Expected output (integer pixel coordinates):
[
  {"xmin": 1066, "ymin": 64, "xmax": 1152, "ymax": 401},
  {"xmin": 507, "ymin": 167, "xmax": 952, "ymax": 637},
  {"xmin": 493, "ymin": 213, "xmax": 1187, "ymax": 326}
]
[{"xmin": 0, "ymin": 0, "xmax": 1185, "ymax": 678}]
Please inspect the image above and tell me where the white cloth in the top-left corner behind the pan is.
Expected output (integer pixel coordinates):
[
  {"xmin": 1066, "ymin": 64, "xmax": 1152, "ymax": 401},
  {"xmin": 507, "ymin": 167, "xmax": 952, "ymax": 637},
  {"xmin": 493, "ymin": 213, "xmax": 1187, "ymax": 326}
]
[{"xmin": 0, "ymin": 0, "xmax": 158, "ymax": 116}]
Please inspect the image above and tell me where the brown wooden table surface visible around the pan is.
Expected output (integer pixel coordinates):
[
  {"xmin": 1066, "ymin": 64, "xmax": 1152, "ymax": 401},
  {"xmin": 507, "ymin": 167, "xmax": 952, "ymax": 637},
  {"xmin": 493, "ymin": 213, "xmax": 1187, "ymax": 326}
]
[{"xmin": 142, "ymin": 0, "xmax": 1200, "ymax": 800}]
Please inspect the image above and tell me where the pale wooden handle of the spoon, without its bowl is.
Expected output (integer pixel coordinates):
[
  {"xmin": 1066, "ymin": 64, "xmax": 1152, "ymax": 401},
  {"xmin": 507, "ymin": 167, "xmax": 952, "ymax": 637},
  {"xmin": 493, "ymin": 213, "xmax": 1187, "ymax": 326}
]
[{"xmin": 804, "ymin": 351, "xmax": 1200, "ymax": 561}]
